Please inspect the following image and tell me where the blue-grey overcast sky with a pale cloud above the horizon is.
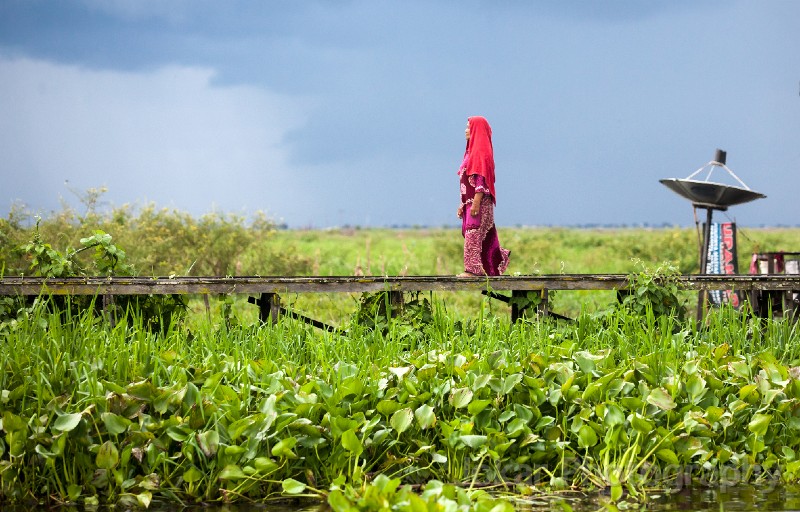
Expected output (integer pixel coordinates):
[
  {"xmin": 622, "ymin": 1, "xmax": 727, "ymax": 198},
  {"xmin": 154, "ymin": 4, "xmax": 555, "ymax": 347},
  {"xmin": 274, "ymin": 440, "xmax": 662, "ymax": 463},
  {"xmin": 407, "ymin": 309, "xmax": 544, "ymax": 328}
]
[{"xmin": 0, "ymin": 0, "xmax": 800, "ymax": 227}]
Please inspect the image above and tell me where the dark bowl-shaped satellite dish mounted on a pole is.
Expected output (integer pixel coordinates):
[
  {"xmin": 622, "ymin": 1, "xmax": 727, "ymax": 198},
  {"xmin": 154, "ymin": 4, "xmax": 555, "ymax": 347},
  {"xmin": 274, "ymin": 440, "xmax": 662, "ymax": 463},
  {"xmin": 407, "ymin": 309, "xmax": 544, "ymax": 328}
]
[{"xmin": 659, "ymin": 149, "xmax": 767, "ymax": 210}]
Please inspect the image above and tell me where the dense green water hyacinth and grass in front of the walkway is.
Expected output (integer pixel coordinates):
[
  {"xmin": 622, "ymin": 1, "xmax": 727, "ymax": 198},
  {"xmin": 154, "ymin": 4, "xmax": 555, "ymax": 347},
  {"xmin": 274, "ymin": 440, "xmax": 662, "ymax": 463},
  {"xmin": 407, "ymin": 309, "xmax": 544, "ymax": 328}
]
[{"xmin": 0, "ymin": 290, "xmax": 800, "ymax": 510}]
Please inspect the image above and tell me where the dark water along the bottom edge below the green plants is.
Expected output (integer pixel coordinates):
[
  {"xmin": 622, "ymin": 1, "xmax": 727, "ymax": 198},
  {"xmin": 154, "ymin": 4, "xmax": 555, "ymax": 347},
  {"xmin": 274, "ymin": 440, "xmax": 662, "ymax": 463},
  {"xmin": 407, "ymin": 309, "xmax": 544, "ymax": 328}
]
[{"xmin": 9, "ymin": 485, "xmax": 800, "ymax": 512}]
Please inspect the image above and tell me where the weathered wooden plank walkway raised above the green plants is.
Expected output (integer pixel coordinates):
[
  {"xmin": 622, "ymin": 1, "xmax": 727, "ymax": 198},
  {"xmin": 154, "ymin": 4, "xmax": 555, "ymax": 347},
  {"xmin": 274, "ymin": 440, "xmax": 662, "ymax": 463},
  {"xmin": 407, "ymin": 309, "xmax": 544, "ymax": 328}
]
[{"xmin": 0, "ymin": 274, "xmax": 800, "ymax": 295}]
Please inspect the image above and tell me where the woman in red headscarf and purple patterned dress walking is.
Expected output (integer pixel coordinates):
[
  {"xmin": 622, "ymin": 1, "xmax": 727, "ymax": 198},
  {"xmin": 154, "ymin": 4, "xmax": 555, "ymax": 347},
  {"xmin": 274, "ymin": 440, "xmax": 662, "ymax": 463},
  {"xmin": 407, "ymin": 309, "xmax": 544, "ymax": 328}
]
[{"xmin": 458, "ymin": 116, "xmax": 511, "ymax": 277}]
